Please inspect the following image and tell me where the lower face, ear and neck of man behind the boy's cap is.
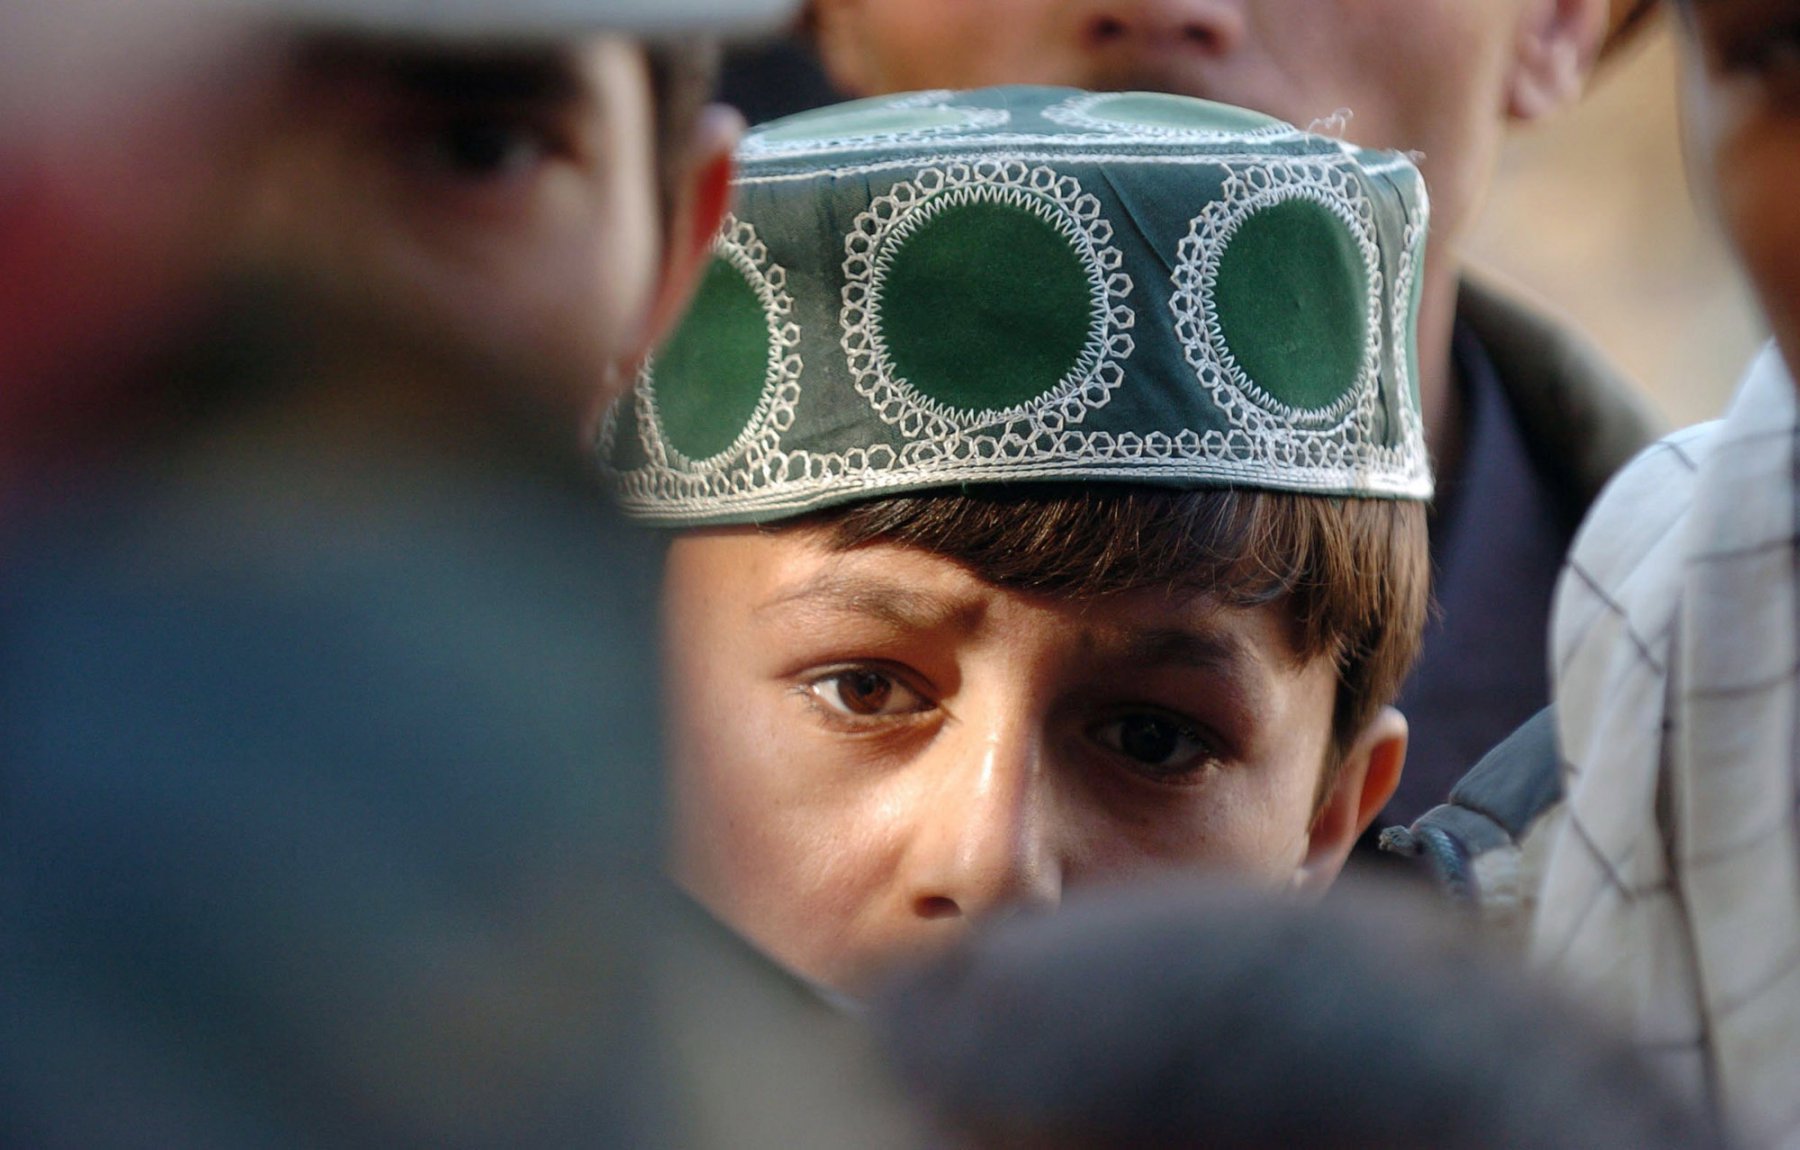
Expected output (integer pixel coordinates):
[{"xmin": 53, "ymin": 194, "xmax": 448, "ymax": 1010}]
[{"xmin": 814, "ymin": 0, "xmax": 1606, "ymax": 250}]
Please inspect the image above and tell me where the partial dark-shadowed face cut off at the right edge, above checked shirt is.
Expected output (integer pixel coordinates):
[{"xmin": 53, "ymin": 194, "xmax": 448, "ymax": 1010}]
[{"xmin": 1683, "ymin": 0, "xmax": 1800, "ymax": 374}]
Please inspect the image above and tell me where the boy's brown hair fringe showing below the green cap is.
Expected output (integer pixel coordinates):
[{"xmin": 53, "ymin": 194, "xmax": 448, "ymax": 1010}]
[{"xmin": 810, "ymin": 484, "xmax": 1431, "ymax": 794}]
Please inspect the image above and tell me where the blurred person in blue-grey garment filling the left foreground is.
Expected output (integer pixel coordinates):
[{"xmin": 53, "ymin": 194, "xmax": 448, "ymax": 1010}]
[{"xmin": 0, "ymin": 0, "xmax": 914, "ymax": 1146}]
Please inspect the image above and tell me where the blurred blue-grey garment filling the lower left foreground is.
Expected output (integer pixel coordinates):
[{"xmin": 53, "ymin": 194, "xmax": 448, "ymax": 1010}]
[{"xmin": 0, "ymin": 433, "xmax": 673, "ymax": 1150}]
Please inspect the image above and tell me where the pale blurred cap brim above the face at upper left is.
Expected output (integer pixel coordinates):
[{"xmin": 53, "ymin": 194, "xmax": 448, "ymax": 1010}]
[{"xmin": 261, "ymin": 0, "xmax": 799, "ymax": 40}]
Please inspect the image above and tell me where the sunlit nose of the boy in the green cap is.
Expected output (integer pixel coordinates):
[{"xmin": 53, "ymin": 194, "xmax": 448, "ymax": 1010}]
[{"xmin": 904, "ymin": 723, "xmax": 1062, "ymax": 925}]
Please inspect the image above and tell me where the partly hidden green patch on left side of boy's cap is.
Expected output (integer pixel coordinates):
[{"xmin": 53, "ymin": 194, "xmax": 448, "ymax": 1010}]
[{"xmin": 652, "ymin": 256, "xmax": 772, "ymax": 459}]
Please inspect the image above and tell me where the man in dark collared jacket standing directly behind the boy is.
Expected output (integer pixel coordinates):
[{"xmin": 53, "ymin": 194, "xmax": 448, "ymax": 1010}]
[{"xmin": 727, "ymin": 0, "xmax": 1658, "ymax": 845}]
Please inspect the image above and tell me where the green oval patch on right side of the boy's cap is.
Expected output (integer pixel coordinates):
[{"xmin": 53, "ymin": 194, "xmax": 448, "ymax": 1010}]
[{"xmin": 1213, "ymin": 198, "xmax": 1368, "ymax": 410}]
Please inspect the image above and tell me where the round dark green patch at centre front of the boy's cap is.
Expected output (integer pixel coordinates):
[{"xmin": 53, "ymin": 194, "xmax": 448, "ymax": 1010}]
[{"xmin": 878, "ymin": 200, "xmax": 1098, "ymax": 412}]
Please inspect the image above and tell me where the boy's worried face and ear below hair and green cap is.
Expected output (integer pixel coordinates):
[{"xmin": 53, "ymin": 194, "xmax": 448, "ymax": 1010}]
[{"xmin": 666, "ymin": 529, "xmax": 1406, "ymax": 992}]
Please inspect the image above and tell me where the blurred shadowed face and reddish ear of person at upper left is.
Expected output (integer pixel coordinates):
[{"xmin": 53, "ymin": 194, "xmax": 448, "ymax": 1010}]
[{"xmin": 230, "ymin": 5, "xmax": 736, "ymax": 439}]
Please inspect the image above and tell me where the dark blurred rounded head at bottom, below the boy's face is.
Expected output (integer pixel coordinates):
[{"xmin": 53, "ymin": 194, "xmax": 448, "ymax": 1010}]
[{"xmin": 877, "ymin": 884, "xmax": 1721, "ymax": 1150}]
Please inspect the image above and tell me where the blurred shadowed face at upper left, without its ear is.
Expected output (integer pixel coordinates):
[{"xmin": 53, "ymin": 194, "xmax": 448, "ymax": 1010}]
[{"xmin": 239, "ymin": 36, "xmax": 716, "ymax": 422}]
